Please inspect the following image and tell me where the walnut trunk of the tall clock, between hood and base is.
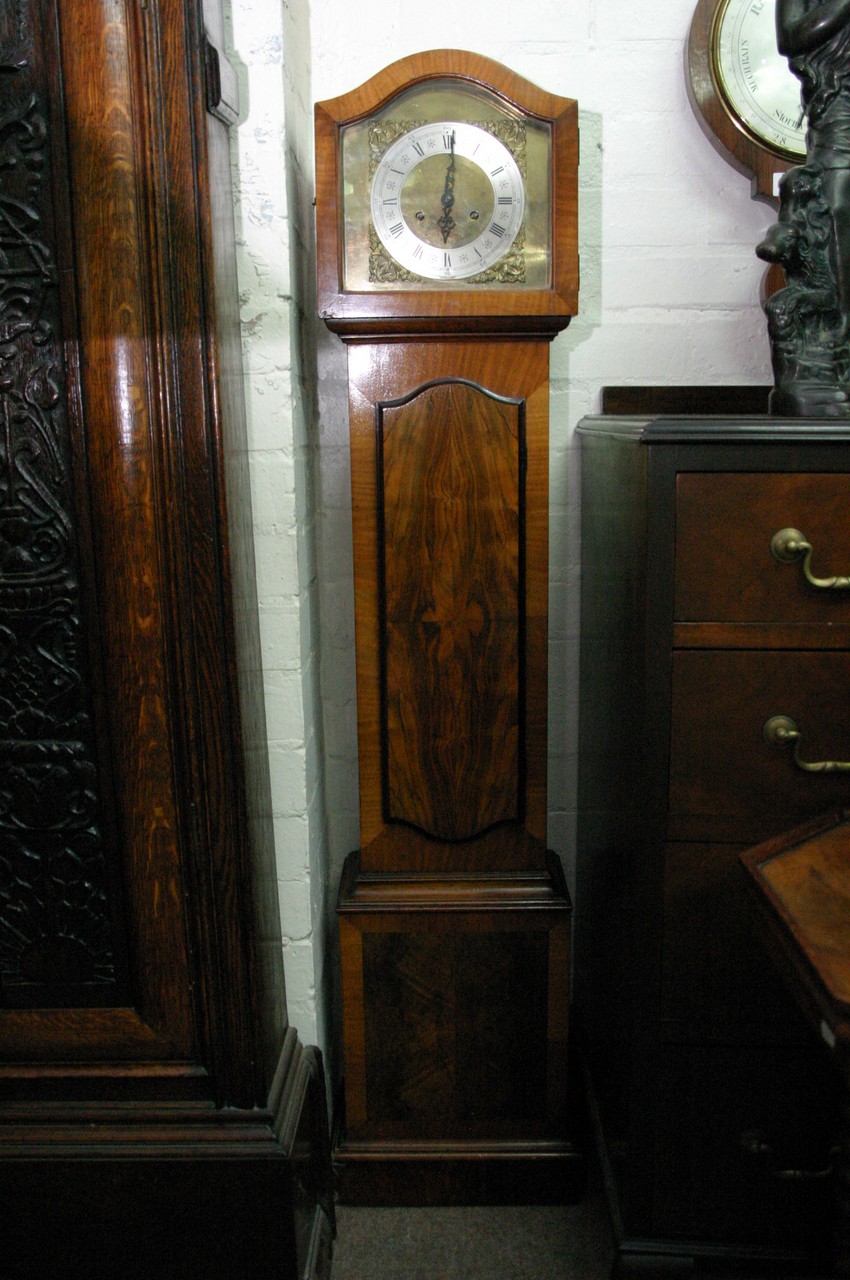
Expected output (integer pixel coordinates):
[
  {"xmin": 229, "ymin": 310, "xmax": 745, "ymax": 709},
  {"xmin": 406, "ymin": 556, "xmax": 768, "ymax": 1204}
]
[{"xmin": 348, "ymin": 342, "xmax": 548, "ymax": 870}]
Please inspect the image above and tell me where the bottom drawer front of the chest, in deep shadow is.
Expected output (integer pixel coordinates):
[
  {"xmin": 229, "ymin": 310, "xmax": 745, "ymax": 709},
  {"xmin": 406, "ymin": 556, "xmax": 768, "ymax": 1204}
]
[{"xmin": 653, "ymin": 1044, "xmax": 836, "ymax": 1244}]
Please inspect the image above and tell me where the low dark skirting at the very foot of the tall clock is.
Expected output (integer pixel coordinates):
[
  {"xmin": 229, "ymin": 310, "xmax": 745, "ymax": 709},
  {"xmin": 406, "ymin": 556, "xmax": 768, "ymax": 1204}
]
[{"xmin": 333, "ymin": 1142, "xmax": 586, "ymax": 1207}]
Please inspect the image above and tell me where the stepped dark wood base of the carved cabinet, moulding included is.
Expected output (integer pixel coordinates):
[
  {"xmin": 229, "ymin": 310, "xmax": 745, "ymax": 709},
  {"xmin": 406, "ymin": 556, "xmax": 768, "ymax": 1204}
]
[{"xmin": 0, "ymin": 1036, "xmax": 333, "ymax": 1280}]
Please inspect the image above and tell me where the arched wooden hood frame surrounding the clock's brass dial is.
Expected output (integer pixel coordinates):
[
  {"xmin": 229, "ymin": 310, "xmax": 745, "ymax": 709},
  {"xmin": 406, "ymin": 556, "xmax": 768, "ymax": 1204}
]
[{"xmin": 315, "ymin": 50, "xmax": 579, "ymax": 338}]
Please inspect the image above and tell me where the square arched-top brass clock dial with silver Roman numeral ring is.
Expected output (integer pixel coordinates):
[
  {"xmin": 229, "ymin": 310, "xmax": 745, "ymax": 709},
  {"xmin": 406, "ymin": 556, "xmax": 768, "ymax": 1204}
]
[{"xmin": 332, "ymin": 79, "xmax": 552, "ymax": 292}]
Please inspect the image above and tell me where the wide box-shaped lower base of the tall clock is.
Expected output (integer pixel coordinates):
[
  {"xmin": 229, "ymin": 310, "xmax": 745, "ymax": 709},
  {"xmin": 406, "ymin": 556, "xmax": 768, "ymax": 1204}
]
[{"xmin": 334, "ymin": 854, "xmax": 584, "ymax": 1204}]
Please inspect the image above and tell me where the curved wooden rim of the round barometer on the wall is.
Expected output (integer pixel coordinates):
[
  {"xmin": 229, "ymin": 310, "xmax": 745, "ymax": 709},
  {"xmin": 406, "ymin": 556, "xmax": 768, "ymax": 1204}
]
[{"xmin": 685, "ymin": 0, "xmax": 800, "ymax": 207}]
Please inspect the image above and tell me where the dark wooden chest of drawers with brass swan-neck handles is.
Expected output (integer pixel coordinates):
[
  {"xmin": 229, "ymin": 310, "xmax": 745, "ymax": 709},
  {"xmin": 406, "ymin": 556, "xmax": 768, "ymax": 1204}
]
[{"xmin": 575, "ymin": 416, "xmax": 850, "ymax": 1274}]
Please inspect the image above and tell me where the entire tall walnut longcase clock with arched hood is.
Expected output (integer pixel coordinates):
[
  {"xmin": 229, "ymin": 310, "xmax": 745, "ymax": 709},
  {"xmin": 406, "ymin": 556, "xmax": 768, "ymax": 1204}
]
[{"xmin": 316, "ymin": 50, "xmax": 580, "ymax": 1202}]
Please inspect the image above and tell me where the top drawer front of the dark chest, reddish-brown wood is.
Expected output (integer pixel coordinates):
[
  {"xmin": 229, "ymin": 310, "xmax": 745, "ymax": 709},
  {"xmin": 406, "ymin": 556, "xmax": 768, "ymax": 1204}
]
[{"xmin": 675, "ymin": 472, "xmax": 850, "ymax": 625}]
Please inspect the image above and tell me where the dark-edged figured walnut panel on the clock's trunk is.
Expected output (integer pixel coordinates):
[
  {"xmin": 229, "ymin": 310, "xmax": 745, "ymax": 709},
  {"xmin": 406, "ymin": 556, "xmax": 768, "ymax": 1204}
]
[{"xmin": 379, "ymin": 380, "xmax": 525, "ymax": 840}]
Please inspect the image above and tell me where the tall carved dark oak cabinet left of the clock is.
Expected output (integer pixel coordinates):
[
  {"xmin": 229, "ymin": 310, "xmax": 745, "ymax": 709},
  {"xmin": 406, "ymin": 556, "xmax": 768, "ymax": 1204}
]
[{"xmin": 0, "ymin": 0, "xmax": 333, "ymax": 1277}]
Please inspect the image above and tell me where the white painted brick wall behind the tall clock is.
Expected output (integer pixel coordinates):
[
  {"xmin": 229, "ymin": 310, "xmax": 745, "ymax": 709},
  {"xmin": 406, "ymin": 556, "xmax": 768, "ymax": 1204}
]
[{"xmin": 224, "ymin": 0, "xmax": 774, "ymax": 1070}]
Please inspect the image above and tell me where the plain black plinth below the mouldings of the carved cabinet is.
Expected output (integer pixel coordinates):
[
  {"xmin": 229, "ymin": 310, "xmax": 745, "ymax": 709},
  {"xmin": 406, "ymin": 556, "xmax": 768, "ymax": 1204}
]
[{"xmin": 0, "ymin": 1157, "xmax": 333, "ymax": 1280}]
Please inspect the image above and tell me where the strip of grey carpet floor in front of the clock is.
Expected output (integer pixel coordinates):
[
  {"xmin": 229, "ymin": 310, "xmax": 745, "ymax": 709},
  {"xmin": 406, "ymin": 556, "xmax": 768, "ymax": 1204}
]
[{"xmin": 332, "ymin": 1190, "xmax": 613, "ymax": 1280}]
